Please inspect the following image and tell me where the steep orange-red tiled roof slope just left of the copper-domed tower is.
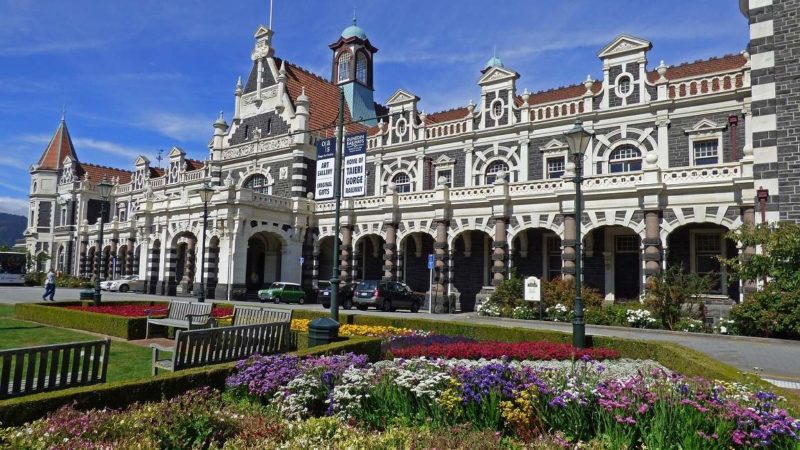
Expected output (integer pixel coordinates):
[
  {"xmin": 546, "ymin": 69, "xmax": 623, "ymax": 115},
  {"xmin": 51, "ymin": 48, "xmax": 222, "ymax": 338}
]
[{"xmin": 273, "ymin": 57, "xmax": 367, "ymax": 136}]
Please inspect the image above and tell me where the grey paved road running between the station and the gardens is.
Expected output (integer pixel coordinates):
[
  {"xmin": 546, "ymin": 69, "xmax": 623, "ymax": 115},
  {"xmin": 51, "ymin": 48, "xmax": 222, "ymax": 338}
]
[{"xmin": 0, "ymin": 286, "xmax": 800, "ymax": 383}]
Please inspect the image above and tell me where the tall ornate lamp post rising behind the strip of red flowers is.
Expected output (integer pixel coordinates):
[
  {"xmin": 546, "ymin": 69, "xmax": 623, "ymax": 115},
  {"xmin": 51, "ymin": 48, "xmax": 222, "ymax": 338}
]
[{"xmin": 564, "ymin": 118, "xmax": 592, "ymax": 348}]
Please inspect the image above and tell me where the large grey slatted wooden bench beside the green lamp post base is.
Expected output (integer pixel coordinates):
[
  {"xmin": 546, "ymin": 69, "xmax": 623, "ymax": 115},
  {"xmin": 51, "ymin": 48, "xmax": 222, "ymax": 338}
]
[{"xmin": 150, "ymin": 322, "xmax": 289, "ymax": 375}]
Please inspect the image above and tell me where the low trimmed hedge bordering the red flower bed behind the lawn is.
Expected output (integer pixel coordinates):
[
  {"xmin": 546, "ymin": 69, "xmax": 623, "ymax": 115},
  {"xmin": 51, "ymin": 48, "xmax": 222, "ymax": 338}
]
[{"xmin": 14, "ymin": 301, "xmax": 166, "ymax": 341}]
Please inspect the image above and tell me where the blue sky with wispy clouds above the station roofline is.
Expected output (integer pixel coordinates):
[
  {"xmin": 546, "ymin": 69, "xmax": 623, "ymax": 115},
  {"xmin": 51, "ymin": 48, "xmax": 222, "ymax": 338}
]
[{"xmin": 0, "ymin": 0, "xmax": 748, "ymax": 214}]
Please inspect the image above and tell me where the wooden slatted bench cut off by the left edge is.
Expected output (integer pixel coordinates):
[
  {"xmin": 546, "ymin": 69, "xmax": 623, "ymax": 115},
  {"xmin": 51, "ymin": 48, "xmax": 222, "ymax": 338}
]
[{"xmin": 0, "ymin": 339, "xmax": 111, "ymax": 399}]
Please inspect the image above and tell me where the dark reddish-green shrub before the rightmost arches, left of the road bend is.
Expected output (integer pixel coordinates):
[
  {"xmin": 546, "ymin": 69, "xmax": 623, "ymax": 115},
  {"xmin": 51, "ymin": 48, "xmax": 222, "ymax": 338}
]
[{"xmin": 645, "ymin": 265, "xmax": 711, "ymax": 330}]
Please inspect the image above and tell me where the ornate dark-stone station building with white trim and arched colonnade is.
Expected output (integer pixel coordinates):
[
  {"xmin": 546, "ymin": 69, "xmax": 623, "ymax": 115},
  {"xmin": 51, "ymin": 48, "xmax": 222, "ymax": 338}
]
[{"xmin": 26, "ymin": 0, "xmax": 800, "ymax": 311}]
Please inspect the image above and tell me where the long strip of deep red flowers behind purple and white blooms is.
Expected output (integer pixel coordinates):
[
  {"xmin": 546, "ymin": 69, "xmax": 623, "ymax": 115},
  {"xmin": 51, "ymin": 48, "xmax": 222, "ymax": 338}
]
[{"xmin": 391, "ymin": 341, "xmax": 619, "ymax": 360}]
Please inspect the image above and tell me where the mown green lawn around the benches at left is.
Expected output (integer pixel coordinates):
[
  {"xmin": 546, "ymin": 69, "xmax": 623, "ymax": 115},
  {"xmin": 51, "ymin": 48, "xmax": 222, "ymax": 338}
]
[{"xmin": 0, "ymin": 305, "xmax": 151, "ymax": 381}]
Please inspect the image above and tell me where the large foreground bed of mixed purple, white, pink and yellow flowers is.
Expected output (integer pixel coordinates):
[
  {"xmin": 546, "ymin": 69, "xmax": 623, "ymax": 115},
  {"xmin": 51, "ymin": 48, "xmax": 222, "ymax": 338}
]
[{"xmin": 0, "ymin": 354, "xmax": 800, "ymax": 450}]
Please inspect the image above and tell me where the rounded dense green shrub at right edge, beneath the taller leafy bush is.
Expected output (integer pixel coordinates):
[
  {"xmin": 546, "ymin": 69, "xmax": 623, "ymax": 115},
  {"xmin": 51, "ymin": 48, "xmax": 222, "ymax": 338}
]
[{"xmin": 728, "ymin": 283, "xmax": 800, "ymax": 339}]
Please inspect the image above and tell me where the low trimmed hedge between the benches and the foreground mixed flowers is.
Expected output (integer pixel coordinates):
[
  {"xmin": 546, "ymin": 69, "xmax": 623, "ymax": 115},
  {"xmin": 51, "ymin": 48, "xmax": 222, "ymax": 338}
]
[{"xmin": 0, "ymin": 335, "xmax": 381, "ymax": 427}]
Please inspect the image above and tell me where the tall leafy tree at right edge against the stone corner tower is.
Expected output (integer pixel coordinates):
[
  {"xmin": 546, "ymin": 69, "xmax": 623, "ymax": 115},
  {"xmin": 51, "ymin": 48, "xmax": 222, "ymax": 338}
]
[{"xmin": 722, "ymin": 222, "xmax": 800, "ymax": 291}]
